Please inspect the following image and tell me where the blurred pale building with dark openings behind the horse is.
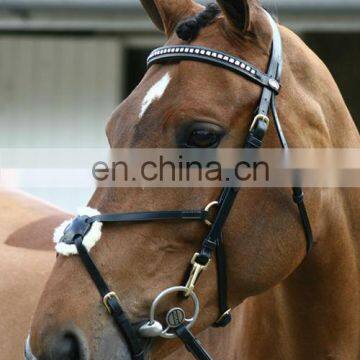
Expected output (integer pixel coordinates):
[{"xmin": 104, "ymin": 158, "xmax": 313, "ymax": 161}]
[{"xmin": 0, "ymin": 0, "xmax": 360, "ymax": 211}]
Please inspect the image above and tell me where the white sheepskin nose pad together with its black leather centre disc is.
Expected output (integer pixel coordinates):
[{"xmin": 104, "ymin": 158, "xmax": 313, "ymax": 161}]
[{"xmin": 54, "ymin": 207, "xmax": 102, "ymax": 256}]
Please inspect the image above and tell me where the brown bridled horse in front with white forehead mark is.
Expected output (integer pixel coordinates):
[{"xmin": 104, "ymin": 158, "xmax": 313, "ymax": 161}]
[{"xmin": 26, "ymin": 0, "xmax": 360, "ymax": 360}]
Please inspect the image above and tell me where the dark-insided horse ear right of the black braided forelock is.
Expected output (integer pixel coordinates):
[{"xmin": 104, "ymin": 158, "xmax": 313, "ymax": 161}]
[{"xmin": 217, "ymin": 0, "xmax": 257, "ymax": 33}]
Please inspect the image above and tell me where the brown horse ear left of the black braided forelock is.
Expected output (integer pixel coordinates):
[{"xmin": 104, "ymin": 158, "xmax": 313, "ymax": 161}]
[{"xmin": 140, "ymin": 0, "xmax": 203, "ymax": 37}]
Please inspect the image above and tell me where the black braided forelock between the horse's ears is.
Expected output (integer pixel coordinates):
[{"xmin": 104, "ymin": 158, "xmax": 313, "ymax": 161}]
[{"xmin": 176, "ymin": 4, "xmax": 221, "ymax": 41}]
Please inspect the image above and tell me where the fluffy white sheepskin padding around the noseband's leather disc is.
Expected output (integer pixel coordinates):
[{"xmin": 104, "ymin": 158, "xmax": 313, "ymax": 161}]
[{"xmin": 54, "ymin": 207, "xmax": 102, "ymax": 256}]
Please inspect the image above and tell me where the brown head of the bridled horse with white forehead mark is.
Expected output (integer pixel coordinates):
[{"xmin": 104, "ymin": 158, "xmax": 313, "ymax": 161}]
[{"xmin": 28, "ymin": 0, "xmax": 326, "ymax": 359}]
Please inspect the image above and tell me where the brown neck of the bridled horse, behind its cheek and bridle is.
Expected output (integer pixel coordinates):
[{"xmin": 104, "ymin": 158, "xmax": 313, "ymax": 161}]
[{"xmin": 207, "ymin": 23, "xmax": 360, "ymax": 360}]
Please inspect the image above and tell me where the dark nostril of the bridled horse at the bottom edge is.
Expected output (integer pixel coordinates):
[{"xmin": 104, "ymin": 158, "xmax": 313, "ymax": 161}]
[{"xmin": 51, "ymin": 332, "xmax": 83, "ymax": 360}]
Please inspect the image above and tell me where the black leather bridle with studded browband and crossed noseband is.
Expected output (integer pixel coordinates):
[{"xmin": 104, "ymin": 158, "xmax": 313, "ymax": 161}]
[{"xmin": 55, "ymin": 14, "xmax": 313, "ymax": 360}]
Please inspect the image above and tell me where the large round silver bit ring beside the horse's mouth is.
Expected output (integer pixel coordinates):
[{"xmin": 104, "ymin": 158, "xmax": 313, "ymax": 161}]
[{"xmin": 150, "ymin": 286, "xmax": 200, "ymax": 339}]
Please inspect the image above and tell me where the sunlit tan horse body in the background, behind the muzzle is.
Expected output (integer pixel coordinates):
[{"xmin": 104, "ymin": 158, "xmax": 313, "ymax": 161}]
[{"xmin": 0, "ymin": 189, "xmax": 71, "ymax": 359}]
